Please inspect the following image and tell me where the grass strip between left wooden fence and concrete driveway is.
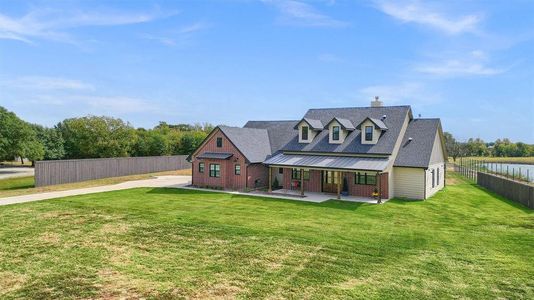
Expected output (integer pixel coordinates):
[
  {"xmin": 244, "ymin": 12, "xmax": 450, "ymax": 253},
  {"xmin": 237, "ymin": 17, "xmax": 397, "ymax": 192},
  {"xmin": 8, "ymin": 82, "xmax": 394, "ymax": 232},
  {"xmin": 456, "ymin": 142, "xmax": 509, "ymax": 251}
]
[{"xmin": 0, "ymin": 169, "xmax": 191, "ymax": 198}]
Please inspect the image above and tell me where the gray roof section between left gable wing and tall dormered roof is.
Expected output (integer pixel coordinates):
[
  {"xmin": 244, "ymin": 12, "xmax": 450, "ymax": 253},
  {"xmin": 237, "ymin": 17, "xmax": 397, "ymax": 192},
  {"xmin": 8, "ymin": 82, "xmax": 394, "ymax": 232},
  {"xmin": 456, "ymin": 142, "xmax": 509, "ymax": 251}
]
[{"xmin": 244, "ymin": 120, "xmax": 302, "ymax": 154}]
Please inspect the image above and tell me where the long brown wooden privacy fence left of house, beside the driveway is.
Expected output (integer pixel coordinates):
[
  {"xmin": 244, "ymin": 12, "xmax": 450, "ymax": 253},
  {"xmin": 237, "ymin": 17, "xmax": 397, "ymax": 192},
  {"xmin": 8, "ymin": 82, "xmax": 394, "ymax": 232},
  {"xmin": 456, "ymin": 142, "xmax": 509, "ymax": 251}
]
[{"xmin": 35, "ymin": 155, "xmax": 191, "ymax": 186}]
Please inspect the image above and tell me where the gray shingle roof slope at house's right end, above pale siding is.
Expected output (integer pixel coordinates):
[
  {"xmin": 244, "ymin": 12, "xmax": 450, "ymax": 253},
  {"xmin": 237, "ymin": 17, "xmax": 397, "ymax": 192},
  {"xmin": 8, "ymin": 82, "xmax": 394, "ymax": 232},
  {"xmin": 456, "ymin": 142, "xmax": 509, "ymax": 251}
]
[{"xmin": 394, "ymin": 119, "xmax": 441, "ymax": 168}]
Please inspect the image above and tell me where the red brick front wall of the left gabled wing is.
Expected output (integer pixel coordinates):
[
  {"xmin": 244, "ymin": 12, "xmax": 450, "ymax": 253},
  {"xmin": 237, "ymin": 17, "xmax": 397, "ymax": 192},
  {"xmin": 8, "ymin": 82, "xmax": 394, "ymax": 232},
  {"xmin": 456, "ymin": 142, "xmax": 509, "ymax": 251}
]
[{"xmin": 192, "ymin": 129, "xmax": 247, "ymax": 190}]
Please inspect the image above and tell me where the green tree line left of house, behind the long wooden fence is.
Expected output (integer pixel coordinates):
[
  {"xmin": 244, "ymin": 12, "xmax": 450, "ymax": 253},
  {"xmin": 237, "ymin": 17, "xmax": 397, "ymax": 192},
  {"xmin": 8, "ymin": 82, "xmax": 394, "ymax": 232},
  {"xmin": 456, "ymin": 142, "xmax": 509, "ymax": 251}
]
[{"xmin": 0, "ymin": 106, "xmax": 214, "ymax": 162}]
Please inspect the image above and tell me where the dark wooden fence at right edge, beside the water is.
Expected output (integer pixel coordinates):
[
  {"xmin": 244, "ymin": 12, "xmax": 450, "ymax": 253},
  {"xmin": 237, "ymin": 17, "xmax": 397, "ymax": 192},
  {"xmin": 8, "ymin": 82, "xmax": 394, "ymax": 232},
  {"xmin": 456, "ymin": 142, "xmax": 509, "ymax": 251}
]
[{"xmin": 476, "ymin": 172, "xmax": 534, "ymax": 209}]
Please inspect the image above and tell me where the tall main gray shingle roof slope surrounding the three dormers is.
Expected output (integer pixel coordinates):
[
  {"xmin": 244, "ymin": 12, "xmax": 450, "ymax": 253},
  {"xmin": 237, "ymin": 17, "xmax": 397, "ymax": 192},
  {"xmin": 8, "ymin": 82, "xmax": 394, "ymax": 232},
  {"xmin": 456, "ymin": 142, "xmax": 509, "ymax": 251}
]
[{"xmin": 281, "ymin": 106, "xmax": 411, "ymax": 154}]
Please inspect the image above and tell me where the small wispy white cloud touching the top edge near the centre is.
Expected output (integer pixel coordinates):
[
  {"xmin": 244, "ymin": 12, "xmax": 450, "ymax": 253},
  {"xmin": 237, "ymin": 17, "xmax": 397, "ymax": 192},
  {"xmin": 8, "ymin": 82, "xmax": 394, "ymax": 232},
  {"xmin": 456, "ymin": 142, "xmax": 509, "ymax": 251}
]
[{"xmin": 264, "ymin": 0, "xmax": 348, "ymax": 27}]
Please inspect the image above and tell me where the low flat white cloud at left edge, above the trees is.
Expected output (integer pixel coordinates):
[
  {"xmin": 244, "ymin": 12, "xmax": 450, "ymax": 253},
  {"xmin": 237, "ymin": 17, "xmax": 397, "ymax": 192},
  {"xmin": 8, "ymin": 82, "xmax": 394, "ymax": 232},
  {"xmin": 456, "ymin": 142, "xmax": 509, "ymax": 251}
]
[{"xmin": 0, "ymin": 76, "xmax": 94, "ymax": 90}]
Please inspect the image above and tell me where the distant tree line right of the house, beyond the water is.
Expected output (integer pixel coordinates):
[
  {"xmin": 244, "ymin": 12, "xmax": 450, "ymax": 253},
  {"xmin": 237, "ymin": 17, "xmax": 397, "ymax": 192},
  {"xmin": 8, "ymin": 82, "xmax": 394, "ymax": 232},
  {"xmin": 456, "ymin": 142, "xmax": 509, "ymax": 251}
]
[{"xmin": 444, "ymin": 132, "xmax": 534, "ymax": 161}]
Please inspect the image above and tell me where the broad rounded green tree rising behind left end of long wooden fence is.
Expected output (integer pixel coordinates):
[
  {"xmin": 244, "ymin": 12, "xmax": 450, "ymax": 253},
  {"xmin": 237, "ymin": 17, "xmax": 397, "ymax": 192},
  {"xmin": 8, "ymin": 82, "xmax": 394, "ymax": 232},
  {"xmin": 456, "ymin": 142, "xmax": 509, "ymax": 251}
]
[{"xmin": 57, "ymin": 116, "xmax": 136, "ymax": 158}]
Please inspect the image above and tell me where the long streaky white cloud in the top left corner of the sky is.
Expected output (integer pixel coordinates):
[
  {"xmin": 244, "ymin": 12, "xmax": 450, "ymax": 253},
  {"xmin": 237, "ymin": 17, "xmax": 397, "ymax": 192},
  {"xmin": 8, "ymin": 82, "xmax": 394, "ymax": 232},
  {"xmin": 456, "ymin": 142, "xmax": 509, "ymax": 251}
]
[{"xmin": 0, "ymin": 9, "xmax": 176, "ymax": 43}]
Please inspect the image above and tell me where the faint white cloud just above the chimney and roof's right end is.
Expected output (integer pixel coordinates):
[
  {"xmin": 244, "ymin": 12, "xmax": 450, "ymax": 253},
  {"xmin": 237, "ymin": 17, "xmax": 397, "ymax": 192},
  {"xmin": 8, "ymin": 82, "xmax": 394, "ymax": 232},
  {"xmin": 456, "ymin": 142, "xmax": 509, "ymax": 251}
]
[{"xmin": 359, "ymin": 82, "xmax": 441, "ymax": 105}]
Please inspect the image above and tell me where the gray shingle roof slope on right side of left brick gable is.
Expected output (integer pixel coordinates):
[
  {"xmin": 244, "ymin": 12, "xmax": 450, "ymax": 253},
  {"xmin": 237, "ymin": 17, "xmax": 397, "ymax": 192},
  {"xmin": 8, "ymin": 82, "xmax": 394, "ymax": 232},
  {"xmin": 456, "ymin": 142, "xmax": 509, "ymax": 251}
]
[{"xmin": 219, "ymin": 126, "xmax": 271, "ymax": 163}]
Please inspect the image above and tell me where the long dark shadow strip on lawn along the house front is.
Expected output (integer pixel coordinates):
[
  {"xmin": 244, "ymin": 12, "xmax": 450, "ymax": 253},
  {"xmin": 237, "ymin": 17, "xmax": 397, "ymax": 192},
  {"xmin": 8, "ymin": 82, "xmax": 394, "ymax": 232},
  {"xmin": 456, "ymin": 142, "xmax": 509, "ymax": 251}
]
[{"xmin": 147, "ymin": 187, "xmax": 371, "ymax": 211}]
